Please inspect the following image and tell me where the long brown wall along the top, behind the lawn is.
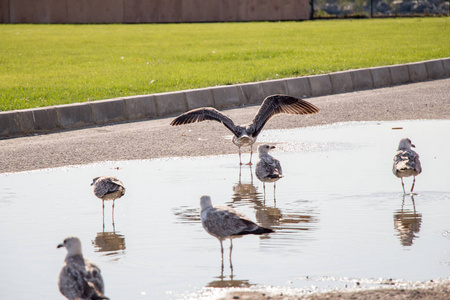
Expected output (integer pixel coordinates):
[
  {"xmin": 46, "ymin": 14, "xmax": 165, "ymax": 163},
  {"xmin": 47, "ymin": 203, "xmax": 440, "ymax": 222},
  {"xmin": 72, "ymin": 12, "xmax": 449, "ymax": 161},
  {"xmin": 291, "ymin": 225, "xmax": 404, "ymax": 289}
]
[{"xmin": 0, "ymin": 0, "xmax": 311, "ymax": 23}]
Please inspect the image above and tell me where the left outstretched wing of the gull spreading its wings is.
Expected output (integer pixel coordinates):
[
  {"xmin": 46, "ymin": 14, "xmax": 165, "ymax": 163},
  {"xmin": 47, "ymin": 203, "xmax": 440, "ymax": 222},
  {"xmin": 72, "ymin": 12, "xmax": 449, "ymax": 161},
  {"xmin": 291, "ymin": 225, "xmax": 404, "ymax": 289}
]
[{"xmin": 170, "ymin": 107, "xmax": 239, "ymax": 136}]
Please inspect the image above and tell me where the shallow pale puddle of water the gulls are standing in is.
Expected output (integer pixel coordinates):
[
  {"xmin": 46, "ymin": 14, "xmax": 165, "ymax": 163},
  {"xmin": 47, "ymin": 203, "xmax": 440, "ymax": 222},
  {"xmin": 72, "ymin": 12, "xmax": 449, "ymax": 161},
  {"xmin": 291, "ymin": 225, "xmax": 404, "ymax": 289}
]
[{"xmin": 0, "ymin": 120, "xmax": 450, "ymax": 299}]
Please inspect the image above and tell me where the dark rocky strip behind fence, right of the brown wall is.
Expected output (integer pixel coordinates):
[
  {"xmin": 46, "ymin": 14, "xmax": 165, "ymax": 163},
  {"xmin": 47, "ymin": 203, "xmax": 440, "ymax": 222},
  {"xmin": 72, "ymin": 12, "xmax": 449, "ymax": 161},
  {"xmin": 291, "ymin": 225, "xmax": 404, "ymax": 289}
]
[{"xmin": 312, "ymin": 0, "xmax": 449, "ymax": 18}]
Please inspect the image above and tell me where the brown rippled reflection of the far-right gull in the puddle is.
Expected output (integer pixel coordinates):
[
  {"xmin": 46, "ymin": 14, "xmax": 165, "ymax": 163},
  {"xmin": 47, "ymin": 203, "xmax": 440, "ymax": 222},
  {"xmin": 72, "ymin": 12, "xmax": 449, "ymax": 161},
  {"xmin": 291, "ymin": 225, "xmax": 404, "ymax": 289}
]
[{"xmin": 394, "ymin": 194, "xmax": 422, "ymax": 246}]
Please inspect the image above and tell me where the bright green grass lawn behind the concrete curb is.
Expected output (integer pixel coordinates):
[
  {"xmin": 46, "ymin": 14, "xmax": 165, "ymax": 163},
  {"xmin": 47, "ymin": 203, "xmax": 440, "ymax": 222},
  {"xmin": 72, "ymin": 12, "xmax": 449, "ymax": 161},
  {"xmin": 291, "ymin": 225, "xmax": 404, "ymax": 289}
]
[{"xmin": 0, "ymin": 17, "xmax": 450, "ymax": 110}]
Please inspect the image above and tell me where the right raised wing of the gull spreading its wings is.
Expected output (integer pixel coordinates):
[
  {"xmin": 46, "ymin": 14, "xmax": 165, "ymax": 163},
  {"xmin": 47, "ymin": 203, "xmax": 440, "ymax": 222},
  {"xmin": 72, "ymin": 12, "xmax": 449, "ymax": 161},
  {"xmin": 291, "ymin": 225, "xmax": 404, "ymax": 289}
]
[{"xmin": 252, "ymin": 95, "xmax": 320, "ymax": 135}]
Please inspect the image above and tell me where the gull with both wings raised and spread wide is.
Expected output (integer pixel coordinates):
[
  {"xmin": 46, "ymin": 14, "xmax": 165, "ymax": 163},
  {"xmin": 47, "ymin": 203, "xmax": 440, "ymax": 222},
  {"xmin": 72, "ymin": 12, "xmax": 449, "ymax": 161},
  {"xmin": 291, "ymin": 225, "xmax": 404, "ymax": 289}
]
[{"xmin": 170, "ymin": 95, "xmax": 319, "ymax": 165}]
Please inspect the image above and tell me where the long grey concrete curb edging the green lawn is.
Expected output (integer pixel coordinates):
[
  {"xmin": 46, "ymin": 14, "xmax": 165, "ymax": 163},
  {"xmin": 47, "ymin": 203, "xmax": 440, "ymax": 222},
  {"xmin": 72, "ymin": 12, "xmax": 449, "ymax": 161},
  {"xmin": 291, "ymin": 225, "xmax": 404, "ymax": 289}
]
[{"xmin": 0, "ymin": 57, "xmax": 450, "ymax": 138}]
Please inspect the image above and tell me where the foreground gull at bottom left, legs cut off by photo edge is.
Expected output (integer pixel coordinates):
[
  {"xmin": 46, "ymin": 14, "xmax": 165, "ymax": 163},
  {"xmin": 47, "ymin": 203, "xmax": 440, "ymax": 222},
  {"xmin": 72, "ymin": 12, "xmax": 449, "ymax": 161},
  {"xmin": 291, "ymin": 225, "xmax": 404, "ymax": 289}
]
[{"xmin": 57, "ymin": 237, "xmax": 109, "ymax": 300}]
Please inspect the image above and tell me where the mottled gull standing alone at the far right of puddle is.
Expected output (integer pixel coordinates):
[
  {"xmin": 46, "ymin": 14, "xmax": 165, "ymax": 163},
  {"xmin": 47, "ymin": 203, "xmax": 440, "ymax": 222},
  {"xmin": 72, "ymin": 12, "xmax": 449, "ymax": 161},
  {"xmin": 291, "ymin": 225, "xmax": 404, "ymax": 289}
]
[{"xmin": 392, "ymin": 138, "xmax": 422, "ymax": 194}]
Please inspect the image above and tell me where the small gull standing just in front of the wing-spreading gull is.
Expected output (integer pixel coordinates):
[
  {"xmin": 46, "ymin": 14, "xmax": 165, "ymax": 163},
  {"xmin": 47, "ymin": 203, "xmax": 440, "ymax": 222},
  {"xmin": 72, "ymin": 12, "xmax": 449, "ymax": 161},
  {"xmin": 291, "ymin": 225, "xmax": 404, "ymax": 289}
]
[{"xmin": 255, "ymin": 144, "xmax": 283, "ymax": 198}]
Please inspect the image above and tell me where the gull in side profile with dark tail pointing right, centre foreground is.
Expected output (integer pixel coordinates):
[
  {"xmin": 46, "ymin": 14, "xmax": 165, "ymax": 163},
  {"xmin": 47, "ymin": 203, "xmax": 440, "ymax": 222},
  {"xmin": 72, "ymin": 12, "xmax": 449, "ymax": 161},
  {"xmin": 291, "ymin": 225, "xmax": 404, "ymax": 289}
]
[{"xmin": 200, "ymin": 196, "xmax": 273, "ymax": 269}]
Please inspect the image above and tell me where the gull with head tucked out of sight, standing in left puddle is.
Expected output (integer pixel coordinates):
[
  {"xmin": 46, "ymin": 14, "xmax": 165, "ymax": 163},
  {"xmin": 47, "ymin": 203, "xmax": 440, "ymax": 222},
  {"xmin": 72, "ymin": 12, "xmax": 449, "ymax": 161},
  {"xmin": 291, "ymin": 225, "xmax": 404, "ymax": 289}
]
[{"xmin": 91, "ymin": 176, "xmax": 125, "ymax": 223}]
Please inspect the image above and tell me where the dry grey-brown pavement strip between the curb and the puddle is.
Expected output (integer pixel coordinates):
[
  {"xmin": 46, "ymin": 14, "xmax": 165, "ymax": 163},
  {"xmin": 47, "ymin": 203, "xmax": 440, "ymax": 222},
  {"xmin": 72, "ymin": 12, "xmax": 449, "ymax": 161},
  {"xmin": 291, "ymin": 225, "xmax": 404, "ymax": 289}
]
[{"xmin": 0, "ymin": 78, "xmax": 450, "ymax": 173}]
